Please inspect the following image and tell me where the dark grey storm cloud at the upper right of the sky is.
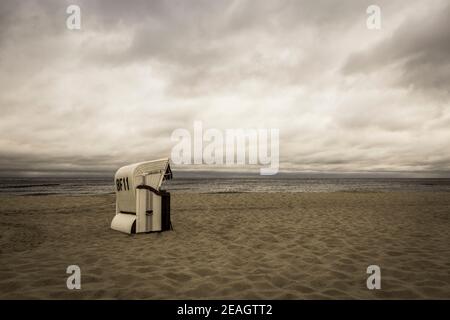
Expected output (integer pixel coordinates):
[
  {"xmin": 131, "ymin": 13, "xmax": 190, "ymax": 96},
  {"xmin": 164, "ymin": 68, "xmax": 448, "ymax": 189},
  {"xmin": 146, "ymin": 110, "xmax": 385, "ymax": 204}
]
[{"xmin": 343, "ymin": 3, "xmax": 450, "ymax": 93}]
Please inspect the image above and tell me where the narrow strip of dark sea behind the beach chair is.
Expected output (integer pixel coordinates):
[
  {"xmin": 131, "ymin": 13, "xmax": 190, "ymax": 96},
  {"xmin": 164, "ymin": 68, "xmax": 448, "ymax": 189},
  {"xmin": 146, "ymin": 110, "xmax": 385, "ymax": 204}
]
[{"xmin": 0, "ymin": 174, "xmax": 450, "ymax": 195}]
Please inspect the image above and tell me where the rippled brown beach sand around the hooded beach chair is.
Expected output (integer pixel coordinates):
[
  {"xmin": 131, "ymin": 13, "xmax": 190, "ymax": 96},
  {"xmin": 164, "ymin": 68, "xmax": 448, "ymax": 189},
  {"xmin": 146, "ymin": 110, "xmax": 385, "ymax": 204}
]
[{"xmin": 0, "ymin": 192, "xmax": 450, "ymax": 299}]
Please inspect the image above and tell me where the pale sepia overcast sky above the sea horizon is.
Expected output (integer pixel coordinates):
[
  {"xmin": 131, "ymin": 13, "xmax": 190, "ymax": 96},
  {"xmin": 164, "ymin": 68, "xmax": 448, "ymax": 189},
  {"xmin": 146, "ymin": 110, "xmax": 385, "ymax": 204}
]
[{"xmin": 0, "ymin": 0, "xmax": 450, "ymax": 175}]
